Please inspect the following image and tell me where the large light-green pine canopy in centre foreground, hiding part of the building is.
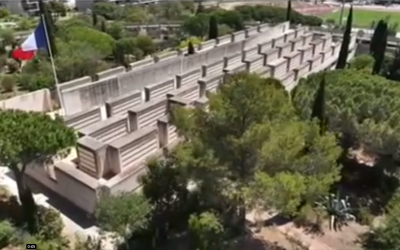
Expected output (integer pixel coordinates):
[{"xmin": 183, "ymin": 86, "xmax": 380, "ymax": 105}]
[{"xmin": 173, "ymin": 74, "xmax": 341, "ymax": 230}]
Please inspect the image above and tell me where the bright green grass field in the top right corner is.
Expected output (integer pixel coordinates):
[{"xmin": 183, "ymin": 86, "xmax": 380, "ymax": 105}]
[{"xmin": 323, "ymin": 9, "xmax": 400, "ymax": 28}]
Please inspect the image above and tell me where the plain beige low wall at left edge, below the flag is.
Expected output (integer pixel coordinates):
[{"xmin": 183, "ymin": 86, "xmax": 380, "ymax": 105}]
[{"xmin": 0, "ymin": 89, "xmax": 53, "ymax": 112}]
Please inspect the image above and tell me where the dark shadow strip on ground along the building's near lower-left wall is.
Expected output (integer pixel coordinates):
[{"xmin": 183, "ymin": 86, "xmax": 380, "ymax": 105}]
[{"xmin": 6, "ymin": 171, "xmax": 97, "ymax": 229}]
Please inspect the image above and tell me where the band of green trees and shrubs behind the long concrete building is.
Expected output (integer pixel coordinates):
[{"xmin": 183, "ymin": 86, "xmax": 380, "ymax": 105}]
[{"xmin": 0, "ymin": 1, "xmax": 322, "ymax": 93}]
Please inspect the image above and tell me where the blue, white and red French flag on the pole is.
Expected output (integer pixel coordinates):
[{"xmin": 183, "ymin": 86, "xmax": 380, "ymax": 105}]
[{"xmin": 13, "ymin": 17, "xmax": 49, "ymax": 61}]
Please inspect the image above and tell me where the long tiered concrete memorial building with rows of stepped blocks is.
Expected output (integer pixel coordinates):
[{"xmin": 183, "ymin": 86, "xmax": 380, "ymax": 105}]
[{"xmin": 27, "ymin": 23, "xmax": 356, "ymax": 213}]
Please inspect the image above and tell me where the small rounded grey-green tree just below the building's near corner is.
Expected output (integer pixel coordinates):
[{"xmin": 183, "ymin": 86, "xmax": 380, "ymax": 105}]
[{"xmin": 96, "ymin": 192, "xmax": 151, "ymax": 250}]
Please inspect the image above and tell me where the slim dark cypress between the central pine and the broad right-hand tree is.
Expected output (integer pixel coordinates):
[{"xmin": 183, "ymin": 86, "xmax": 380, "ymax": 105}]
[{"xmin": 311, "ymin": 74, "xmax": 327, "ymax": 134}]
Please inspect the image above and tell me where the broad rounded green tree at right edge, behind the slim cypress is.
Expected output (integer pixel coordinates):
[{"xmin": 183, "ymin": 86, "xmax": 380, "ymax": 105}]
[{"xmin": 294, "ymin": 70, "xmax": 400, "ymax": 158}]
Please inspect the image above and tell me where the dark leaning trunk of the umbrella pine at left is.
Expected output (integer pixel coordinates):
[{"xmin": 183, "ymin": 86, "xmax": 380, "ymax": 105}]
[{"xmin": 12, "ymin": 169, "xmax": 39, "ymax": 234}]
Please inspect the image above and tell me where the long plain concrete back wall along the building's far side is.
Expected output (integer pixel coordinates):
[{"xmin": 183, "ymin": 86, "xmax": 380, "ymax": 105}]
[{"xmin": 60, "ymin": 22, "xmax": 289, "ymax": 115}]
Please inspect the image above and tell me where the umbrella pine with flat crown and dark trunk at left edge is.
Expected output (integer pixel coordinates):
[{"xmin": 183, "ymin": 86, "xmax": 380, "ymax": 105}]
[{"xmin": 0, "ymin": 110, "xmax": 77, "ymax": 233}]
